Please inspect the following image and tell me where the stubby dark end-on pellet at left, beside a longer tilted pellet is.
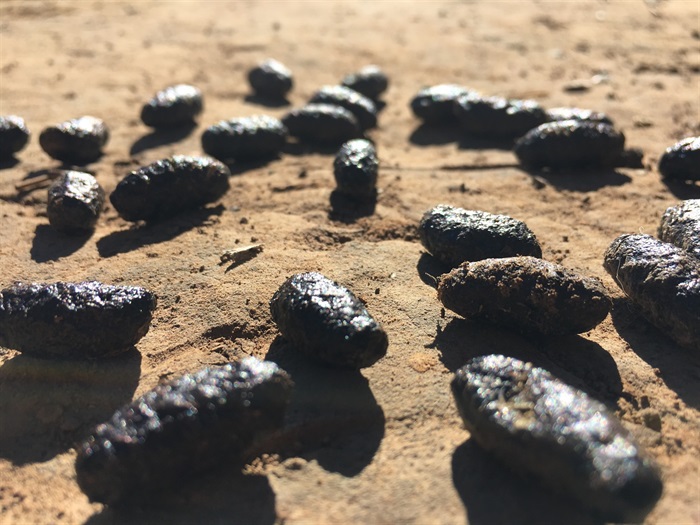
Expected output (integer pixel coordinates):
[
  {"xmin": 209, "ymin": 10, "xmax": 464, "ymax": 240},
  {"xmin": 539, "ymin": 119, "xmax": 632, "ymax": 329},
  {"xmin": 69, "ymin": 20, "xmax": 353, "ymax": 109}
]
[{"xmin": 46, "ymin": 171, "xmax": 105, "ymax": 234}]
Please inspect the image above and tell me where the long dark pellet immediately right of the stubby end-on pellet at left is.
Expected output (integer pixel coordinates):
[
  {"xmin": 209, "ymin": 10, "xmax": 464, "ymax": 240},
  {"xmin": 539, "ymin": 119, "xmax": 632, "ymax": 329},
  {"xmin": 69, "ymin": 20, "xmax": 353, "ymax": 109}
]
[{"xmin": 109, "ymin": 155, "xmax": 231, "ymax": 221}]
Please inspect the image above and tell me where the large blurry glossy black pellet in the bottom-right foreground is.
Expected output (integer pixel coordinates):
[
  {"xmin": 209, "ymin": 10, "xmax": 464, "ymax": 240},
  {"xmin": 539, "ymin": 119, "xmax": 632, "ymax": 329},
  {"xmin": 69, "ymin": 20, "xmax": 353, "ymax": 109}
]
[{"xmin": 451, "ymin": 355, "xmax": 663, "ymax": 523}]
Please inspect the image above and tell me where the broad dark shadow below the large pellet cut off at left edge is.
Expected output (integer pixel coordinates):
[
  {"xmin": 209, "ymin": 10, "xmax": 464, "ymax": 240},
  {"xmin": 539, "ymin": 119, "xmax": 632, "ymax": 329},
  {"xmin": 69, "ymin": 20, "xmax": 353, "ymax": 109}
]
[{"xmin": 0, "ymin": 348, "xmax": 141, "ymax": 465}]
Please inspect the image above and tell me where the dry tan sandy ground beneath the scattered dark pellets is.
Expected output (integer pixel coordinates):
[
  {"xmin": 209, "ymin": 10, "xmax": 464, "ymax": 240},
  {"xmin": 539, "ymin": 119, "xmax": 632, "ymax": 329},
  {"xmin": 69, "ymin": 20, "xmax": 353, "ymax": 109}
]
[{"xmin": 0, "ymin": 0, "xmax": 700, "ymax": 525}]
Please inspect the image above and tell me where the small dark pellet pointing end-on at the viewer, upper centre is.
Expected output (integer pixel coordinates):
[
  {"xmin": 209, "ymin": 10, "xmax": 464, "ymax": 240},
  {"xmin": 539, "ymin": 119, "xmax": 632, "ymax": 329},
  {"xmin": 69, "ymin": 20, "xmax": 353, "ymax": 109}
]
[{"xmin": 333, "ymin": 139, "xmax": 379, "ymax": 199}]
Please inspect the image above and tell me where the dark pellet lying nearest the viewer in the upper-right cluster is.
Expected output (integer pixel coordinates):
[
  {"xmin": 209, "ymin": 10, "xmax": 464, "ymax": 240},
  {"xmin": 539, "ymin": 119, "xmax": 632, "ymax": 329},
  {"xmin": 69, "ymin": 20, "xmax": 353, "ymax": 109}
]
[{"xmin": 514, "ymin": 120, "xmax": 625, "ymax": 169}]
